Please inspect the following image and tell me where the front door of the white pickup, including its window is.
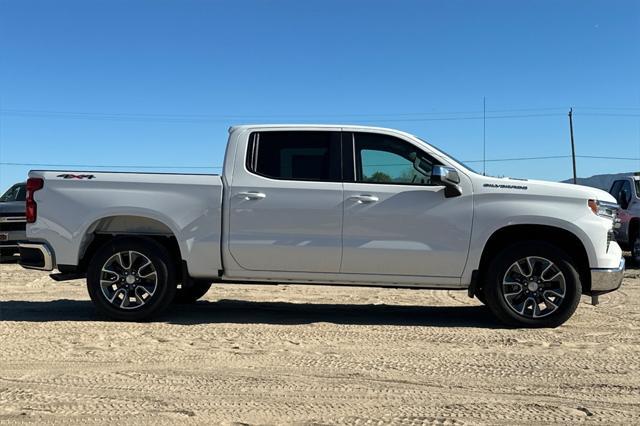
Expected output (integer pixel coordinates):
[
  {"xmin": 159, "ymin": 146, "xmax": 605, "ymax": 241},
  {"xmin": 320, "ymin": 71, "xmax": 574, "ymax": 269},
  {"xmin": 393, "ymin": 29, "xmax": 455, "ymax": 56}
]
[{"xmin": 341, "ymin": 133, "xmax": 473, "ymax": 277}]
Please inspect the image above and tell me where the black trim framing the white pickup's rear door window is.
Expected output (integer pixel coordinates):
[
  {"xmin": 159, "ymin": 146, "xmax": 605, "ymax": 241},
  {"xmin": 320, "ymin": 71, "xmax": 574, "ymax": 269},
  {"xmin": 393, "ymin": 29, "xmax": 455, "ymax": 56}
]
[{"xmin": 244, "ymin": 129, "xmax": 344, "ymax": 183}]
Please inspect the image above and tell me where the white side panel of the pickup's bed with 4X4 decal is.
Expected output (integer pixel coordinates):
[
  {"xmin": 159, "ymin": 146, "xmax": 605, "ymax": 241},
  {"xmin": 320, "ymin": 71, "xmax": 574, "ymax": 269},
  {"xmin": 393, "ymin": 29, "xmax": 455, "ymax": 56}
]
[{"xmin": 29, "ymin": 170, "xmax": 223, "ymax": 278}]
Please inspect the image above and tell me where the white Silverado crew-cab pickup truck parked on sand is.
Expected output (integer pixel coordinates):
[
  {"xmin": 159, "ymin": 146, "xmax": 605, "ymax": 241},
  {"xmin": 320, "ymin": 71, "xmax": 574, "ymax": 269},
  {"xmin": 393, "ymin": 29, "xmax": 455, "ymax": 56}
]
[{"xmin": 20, "ymin": 125, "xmax": 624, "ymax": 327}]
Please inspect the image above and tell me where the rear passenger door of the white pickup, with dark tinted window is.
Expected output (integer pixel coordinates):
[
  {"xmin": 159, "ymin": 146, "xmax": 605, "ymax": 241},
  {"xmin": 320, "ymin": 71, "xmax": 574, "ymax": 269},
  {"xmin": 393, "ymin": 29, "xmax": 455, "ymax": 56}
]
[{"xmin": 228, "ymin": 130, "xmax": 343, "ymax": 273}]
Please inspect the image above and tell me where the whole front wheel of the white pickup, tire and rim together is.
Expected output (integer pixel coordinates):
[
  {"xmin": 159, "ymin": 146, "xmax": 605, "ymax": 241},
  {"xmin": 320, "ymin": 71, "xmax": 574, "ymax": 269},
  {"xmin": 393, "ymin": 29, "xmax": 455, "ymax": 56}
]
[{"xmin": 484, "ymin": 241, "xmax": 582, "ymax": 327}]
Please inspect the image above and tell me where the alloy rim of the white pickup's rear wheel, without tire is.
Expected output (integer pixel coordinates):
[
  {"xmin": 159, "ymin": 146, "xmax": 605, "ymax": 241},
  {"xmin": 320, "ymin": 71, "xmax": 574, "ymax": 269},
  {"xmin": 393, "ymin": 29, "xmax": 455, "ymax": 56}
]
[{"xmin": 100, "ymin": 250, "xmax": 158, "ymax": 309}]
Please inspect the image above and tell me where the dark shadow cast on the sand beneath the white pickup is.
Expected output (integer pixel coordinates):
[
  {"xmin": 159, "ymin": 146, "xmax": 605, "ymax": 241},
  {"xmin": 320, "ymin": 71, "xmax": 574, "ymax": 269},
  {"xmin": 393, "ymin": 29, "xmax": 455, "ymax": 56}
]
[{"xmin": 0, "ymin": 299, "xmax": 504, "ymax": 328}]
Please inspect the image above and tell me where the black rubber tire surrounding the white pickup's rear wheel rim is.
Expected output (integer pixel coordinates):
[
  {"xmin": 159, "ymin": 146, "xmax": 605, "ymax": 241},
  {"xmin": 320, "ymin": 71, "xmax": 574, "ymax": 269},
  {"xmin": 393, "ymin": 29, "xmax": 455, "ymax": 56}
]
[{"xmin": 87, "ymin": 238, "xmax": 176, "ymax": 321}]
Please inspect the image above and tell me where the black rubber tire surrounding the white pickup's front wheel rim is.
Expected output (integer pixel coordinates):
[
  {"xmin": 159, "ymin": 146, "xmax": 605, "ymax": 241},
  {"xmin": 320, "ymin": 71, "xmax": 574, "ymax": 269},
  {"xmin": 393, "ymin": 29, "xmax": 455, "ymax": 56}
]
[{"xmin": 485, "ymin": 241, "xmax": 582, "ymax": 327}]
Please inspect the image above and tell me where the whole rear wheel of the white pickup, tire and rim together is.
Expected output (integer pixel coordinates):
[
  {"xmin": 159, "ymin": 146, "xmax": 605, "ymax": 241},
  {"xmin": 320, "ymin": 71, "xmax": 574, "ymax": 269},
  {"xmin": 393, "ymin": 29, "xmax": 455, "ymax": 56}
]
[{"xmin": 87, "ymin": 237, "xmax": 177, "ymax": 321}]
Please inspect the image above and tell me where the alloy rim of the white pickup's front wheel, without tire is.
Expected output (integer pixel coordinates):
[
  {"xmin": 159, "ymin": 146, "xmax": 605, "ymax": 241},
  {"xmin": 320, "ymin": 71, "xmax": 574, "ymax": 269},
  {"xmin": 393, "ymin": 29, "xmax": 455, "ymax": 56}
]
[{"xmin": 502, "ymin": 256, "xmax": 567, "ymax": 318}]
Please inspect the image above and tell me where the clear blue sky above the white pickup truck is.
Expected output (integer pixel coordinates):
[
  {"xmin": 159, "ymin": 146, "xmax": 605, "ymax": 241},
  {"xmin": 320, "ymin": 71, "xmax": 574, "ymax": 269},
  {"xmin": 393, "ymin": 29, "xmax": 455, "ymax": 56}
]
[{"xmin": 0, "ymin": 0, "xmax": 640, "ymax": 190}]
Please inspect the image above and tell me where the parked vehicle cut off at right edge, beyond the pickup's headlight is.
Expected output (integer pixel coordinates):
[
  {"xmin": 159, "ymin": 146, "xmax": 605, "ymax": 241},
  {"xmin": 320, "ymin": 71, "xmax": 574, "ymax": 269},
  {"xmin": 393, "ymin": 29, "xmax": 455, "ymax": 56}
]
[{"xmin": 609, "ymin": 175, "xmax": 640, "ymax": 265}]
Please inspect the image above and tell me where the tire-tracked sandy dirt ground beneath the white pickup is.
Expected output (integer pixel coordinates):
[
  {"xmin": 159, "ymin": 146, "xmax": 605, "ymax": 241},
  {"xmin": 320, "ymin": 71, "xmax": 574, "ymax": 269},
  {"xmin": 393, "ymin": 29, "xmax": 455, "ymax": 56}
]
[{"xmin": 0, "ymin": 258, "xmax": 640, "ymax": 425}]
